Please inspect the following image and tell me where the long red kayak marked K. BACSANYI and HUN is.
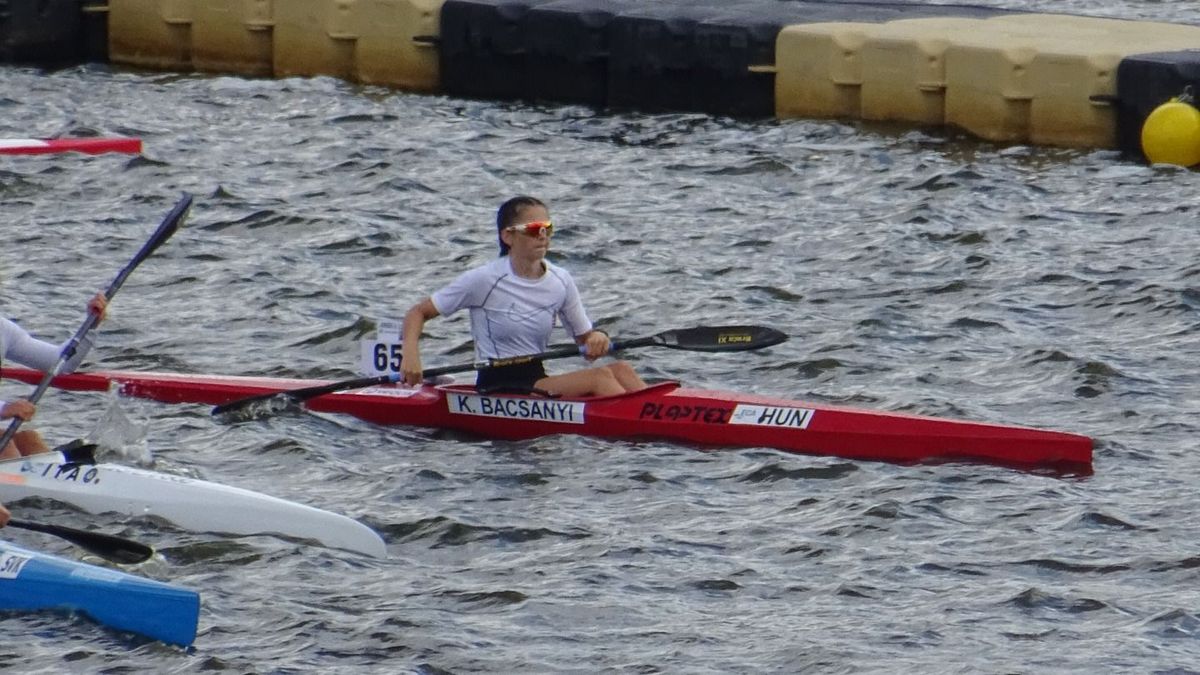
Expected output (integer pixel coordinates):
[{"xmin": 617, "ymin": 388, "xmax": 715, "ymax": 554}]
[{"xmin": 0, "ymin": 368, "xmax": 1092, "ymax": 474}]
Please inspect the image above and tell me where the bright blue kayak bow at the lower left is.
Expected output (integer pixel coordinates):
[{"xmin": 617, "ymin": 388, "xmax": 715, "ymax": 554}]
[{"xmin": 0, "ymin": 542, "xmax": 200, "ymax": 646}]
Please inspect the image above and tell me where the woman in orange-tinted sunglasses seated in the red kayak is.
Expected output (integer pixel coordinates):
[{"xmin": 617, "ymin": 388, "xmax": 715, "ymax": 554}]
[{"xmin": 401, "ymin": 197, "xmax": 646, "ymax": 396}]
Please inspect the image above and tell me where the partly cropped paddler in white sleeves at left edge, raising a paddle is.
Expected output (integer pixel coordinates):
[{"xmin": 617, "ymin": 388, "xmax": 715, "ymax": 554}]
[{"xmin": 0, "ymin": 292, "xmax": 108, "ymax": 460}]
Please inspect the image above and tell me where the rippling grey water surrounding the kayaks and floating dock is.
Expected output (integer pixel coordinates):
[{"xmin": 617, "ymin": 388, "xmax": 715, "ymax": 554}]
[{"xmin": 0, "ymin": 0, "xmax": 1200, "ymax": 673}]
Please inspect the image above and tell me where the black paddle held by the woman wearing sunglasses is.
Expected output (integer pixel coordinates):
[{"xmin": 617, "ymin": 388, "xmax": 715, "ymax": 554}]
[{"xmin": 212, "ymin": 325, "xmax": 787, "ymax": 414}]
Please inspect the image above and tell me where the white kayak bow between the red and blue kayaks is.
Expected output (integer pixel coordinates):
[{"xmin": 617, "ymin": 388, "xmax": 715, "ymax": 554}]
[{"xmin": 0, "ymin": 453, "xmax": 386, "ymax": 557}]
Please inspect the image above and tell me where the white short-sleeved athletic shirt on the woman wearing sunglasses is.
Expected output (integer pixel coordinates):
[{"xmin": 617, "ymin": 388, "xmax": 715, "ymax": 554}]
[{"xmin": 430, "ymin": 256, "xmax": 592, "ymax": 359}]
